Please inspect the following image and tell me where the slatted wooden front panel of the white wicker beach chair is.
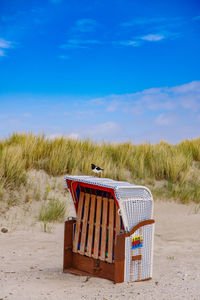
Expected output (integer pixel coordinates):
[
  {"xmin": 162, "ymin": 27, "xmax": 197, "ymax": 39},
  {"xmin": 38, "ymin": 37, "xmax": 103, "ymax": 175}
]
[{"xmin": 73, "ymin": 192, "xmax": 121, "ymax": 263}]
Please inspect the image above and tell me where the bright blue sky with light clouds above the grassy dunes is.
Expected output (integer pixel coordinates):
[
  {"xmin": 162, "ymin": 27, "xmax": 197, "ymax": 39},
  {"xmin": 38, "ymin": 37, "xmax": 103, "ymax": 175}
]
[{"xmin": 0, "ymin": 0, "xmax": 200, "ymax": 144}]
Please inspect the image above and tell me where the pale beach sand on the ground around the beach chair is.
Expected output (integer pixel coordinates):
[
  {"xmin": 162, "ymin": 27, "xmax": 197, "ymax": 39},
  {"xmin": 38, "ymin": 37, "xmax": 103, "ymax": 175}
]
[{"xmin": 0, "ymin": 200, "xmax": 200, "ymax": 300}]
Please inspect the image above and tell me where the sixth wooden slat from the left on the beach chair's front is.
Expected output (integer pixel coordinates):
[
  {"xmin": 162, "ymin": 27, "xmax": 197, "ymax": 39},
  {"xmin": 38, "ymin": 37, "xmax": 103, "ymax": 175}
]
[{"xmin": 107, "ymin": 199, "xmax": 114, "ymax": 263}]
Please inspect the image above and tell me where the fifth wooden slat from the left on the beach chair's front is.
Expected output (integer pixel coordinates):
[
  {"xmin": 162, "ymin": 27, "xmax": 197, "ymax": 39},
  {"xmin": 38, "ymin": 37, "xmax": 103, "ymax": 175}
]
[{"xmin": 100, "ymin": 198, "xmax": 108, "ymax": 260}]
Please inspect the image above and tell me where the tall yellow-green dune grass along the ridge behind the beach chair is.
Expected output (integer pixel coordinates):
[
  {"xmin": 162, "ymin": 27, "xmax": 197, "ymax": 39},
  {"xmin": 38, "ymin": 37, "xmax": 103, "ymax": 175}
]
[{"xmin": 0, "ymin": 133, "xmax": 200, "ymax": 203}]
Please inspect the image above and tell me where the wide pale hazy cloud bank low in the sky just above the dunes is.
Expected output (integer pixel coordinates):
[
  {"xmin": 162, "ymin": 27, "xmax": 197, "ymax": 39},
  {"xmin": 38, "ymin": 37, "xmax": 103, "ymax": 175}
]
[{"xmin": 0, "ymin": 81, "xmax": 200, "ymax": 143}]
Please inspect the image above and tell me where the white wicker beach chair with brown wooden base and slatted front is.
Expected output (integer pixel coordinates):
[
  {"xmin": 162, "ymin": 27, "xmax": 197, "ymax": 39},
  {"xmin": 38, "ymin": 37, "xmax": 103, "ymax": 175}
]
[{"xmin": 63, "ymin": 176, "xmax": 154, "ymax": 283}]
